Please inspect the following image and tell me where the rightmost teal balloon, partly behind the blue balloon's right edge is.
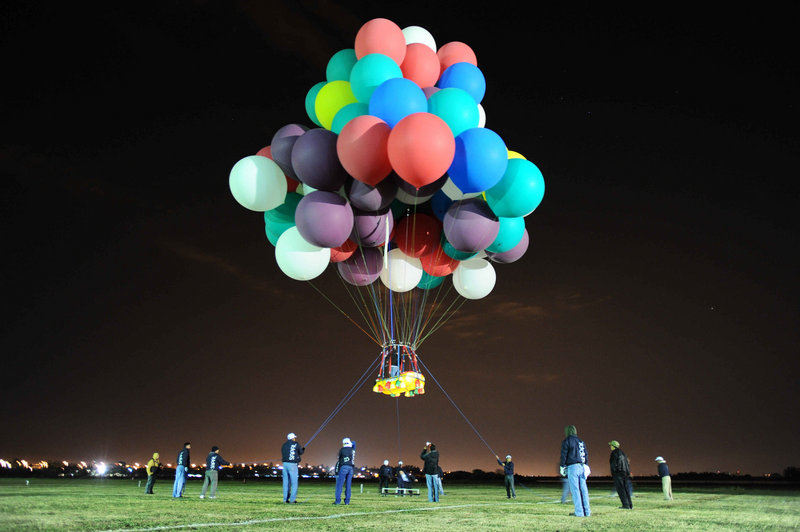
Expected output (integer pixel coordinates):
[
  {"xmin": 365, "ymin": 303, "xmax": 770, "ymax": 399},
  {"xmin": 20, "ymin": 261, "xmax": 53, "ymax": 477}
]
[{"xmin": 486, "ymin": 159, "xmax": 544, "ymax": 218}]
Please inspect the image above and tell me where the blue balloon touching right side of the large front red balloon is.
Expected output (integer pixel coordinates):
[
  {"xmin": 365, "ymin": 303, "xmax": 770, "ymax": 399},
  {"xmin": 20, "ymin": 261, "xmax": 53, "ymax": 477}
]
[{"xmin": 447, "ymin": 127, "xmax": 508, "ymax": 194}]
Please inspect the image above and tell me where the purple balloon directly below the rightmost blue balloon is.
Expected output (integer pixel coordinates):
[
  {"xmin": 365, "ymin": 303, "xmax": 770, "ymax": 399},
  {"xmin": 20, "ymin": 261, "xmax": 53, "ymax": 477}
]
[{"xmin": 442, "ymin": 198, "xmax": 500, "ymax": 253}]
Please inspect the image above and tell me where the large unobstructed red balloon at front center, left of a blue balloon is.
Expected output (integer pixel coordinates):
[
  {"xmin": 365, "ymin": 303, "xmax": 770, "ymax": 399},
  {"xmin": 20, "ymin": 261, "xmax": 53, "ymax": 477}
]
[{"xmin": 388, "ymin": 113, "xmax": 456, "ymax": 188}]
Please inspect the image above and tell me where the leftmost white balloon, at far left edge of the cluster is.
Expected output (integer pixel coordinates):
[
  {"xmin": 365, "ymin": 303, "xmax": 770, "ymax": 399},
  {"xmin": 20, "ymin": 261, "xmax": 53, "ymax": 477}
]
[{"xmin": 228, "ymin": 155, "xmax": 287, "ymax": 212}]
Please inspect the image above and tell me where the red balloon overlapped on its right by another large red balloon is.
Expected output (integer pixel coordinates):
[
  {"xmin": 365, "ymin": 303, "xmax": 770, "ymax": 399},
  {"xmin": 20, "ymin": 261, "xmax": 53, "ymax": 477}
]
[{"xmin": 336, "ymin": 115, "xmax": 392, "ymax": 187}]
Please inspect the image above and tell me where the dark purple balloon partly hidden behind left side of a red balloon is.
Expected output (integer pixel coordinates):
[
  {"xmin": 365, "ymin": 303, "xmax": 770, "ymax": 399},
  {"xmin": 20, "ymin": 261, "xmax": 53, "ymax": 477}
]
[{"xmin": 292, "ymin": 128, "xmax": 347, "ymax": 192}]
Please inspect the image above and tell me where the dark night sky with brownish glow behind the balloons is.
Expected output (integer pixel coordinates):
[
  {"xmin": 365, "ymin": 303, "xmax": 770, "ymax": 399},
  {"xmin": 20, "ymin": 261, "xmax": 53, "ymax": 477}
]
[{"xmin": 0, "ymin": 0, "xmax": 800, "ymax": 475}]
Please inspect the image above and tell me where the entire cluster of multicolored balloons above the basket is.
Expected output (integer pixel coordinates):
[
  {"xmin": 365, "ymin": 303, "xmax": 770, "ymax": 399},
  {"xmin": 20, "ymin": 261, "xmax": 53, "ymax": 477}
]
[{"xmin": 229, "ymin": 18, "xmax": 544, "ymax": 299}]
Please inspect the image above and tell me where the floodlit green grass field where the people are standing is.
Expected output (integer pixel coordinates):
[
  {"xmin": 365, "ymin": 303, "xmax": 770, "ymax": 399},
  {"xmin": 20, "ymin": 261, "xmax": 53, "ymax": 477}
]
[{"xmin": 0, "ymin": 479, "xmax": 800, "ymax": 531}]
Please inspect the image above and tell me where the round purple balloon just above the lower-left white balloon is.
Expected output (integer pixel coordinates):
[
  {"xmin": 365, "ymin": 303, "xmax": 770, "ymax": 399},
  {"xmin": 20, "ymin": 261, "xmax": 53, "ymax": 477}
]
[{"xmin": 294, "ymin": 190, "xmax": 353, "ymax": 248}]
